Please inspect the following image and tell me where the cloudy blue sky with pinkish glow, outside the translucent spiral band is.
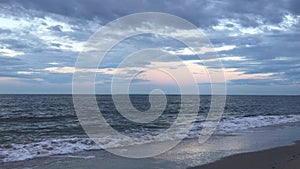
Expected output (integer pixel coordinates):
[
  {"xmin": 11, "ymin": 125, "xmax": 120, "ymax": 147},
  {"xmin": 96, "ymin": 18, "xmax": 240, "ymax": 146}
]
[{"xmin": 0, "ymin": 0, "xmax": 300, "ymax": 95}]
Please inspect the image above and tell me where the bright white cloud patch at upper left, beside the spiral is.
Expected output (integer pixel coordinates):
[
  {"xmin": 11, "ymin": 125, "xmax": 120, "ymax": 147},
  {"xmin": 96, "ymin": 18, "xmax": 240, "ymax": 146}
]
[{"xmin": 0, "ymin": 5, "xmax": 99, "ymax": 53}]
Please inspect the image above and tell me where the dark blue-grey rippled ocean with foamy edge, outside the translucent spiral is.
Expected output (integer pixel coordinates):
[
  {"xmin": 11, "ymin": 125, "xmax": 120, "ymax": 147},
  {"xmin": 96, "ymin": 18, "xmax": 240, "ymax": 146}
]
[{"xmin": 0, "ymin": 95, "xmax": 300, "ymax": 163}]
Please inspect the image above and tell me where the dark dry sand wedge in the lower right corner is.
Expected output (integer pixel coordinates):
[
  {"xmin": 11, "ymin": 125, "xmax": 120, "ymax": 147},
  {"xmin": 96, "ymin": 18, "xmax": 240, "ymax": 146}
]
[{"xmin": 188, "ymin": 140, "xmax": 300, "ymax": 169}]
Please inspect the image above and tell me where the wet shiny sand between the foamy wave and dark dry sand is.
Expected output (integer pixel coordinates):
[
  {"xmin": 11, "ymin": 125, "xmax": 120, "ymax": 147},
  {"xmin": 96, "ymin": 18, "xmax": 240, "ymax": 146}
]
[{"xmin": 0, "ymin": 122, "xmax": 300, "ymax": 169}]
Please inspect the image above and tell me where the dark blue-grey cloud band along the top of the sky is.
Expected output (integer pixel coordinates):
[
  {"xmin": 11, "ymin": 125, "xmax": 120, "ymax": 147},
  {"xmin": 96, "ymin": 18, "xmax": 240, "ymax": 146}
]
[{"xmin": 2, "ymin": 0, "xmax": 299, "ymax": 27}]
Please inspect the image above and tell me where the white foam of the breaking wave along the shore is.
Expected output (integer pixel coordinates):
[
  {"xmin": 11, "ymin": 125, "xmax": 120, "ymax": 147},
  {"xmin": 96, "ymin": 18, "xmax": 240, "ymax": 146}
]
[{"xmin": 0, "ymin": 115, "xmax": 300, "ymax": 162}]
